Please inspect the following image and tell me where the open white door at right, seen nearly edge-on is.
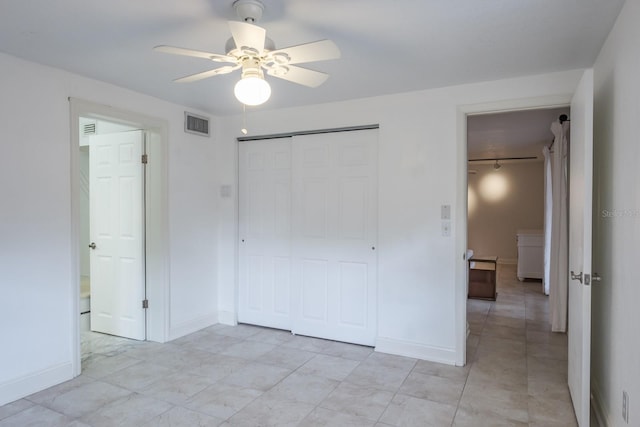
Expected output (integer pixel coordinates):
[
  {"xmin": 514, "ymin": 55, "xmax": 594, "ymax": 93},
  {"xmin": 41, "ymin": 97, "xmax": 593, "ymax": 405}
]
[{"xmin": 568, "ymin": 70, "xmax": 593, "ymax": 427}]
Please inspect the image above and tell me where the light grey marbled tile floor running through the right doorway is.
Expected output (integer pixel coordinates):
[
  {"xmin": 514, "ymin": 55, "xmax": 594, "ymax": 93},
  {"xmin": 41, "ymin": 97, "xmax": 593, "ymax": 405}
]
[{"xmin": 0, "ymin": 266, "xmax": 576, "ymax": 427}]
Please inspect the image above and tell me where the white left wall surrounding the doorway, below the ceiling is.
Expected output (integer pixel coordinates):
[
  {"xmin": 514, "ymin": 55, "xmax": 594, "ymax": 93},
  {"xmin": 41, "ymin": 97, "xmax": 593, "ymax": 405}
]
[{"xmin": 0, "ymin": 54, "xmax": 217, "ymax": 405}]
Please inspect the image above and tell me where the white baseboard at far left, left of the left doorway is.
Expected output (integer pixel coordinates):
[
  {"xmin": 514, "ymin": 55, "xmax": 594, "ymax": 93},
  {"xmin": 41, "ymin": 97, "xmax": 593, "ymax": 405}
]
[{"xmin": 0, "ymin": 361, "xmax": 73, "ymax": 406}]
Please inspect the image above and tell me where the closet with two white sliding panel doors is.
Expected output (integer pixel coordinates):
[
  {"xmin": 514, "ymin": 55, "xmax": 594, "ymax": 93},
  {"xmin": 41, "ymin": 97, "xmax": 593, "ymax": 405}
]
[{"xmin": 238, "ymin": 129, "xmax": 378, "ymax": 345}]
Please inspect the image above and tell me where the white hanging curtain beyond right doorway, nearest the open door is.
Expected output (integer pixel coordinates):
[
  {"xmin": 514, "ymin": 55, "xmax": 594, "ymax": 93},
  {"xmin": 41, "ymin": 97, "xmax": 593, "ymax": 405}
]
[{"xmin": 549, "ymin": 121, "xmax": 569, "ymax": 332}]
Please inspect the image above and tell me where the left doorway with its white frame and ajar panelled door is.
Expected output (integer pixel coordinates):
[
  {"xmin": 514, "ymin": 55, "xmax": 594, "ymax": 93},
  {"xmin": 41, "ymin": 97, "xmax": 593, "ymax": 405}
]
[{"xmin": 70, "ymin": 99, "xmax": 168, "ymax": 374}]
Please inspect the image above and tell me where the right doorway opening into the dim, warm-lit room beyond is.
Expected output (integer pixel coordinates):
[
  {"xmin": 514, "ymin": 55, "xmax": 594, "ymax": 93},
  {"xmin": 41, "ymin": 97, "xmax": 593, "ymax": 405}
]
[{"xmin": 467, "ymin": 107, "xmax": 569, "ymax": 364}]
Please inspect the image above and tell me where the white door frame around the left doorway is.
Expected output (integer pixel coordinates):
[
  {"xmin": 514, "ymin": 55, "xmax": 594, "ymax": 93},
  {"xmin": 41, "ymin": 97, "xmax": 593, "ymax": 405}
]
[{"xmin": 69, "ymin": 98, "xmax": 169, "ymax": 376}]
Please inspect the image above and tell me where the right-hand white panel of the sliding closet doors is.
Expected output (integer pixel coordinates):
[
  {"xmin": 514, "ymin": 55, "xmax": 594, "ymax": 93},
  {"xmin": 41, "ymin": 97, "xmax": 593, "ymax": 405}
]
[{"xmin": 292, "ymin": 130, "xmax": 378, "ymax": 345}]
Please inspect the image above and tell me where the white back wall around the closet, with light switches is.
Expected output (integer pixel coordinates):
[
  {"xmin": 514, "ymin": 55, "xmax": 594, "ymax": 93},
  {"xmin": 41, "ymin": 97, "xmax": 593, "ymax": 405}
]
[{"xmin": 217, "ymin": 71, "xmax": 582, "ymax": 363}]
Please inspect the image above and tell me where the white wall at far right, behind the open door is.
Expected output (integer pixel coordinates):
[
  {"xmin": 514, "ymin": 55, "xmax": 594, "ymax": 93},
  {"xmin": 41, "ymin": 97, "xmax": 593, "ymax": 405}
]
[{"xmin": 591, "ymin": 0, "xmax": 640, "ymax": 426}]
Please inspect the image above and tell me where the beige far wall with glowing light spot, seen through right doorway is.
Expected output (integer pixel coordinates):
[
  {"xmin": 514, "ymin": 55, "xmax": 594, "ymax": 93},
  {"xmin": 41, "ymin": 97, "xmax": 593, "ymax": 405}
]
[{"xmin": 468, "ymin": 161, "xmax": 551, "ymax": 263}]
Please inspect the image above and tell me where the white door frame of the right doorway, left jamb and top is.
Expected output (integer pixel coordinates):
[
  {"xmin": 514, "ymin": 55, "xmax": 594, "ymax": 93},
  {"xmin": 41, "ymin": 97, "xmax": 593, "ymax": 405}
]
[{"xmin": 454, "ymin": 93, "xmax": 573, "ymax": 366}]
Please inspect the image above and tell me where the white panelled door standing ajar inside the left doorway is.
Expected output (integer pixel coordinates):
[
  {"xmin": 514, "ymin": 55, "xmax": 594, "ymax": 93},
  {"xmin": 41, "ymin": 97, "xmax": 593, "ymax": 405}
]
[{"xmin": 89, "ymin": 131, "xmax": 145, "ymax": 340}]
